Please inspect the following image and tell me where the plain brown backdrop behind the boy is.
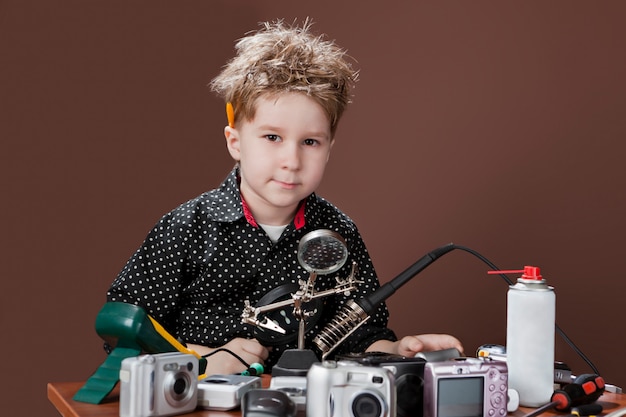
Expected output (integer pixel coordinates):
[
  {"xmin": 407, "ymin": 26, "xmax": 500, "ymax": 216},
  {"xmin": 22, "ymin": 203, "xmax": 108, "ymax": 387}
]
[{"xmin": 0, "ymin": 0, "xmax": 626, "ymax": 416}]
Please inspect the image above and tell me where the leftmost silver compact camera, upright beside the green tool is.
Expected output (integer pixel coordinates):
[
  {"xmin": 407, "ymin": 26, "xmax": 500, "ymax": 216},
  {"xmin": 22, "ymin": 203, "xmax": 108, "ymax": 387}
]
[{"xmin": 120, "ymin": 352, "xmax": 198, "ymax": 417}]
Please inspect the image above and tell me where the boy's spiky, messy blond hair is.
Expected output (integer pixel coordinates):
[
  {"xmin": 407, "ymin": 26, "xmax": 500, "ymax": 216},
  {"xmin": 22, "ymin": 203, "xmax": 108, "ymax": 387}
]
[{"xmin": 210, "ymin": 19, "xmax": 358, "ymax": 135}]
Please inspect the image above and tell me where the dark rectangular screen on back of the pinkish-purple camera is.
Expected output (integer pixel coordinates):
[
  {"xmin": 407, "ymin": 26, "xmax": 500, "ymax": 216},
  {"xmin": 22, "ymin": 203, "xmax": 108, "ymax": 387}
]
[{"xmin": 437, "ymin": 377, "xmax": 484, "ymax": 417}]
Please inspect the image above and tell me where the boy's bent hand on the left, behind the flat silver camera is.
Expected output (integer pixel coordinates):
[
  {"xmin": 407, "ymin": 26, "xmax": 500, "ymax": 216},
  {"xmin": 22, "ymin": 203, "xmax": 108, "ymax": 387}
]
[{"xmin": 188, "ymin": 338, "xmax": 269, "ymax": 376}]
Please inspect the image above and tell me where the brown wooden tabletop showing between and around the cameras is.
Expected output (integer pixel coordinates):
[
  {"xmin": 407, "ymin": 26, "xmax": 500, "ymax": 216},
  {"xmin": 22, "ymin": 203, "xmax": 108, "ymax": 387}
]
[{"xmin": 48, "ymin": 376, "xmax": 626, "ymax": 417}]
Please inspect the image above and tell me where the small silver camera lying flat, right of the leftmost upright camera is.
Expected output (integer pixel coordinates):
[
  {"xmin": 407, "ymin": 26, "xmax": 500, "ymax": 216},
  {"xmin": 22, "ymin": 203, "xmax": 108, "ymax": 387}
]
[{"xmin": 198, "ymin": 374, "xmax": 261, "ymax": 410}]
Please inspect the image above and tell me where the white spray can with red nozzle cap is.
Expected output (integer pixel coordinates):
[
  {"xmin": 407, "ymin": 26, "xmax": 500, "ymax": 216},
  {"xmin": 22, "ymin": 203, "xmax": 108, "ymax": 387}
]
[{"xmin": 506, "ymin": 266, "xmax": 556, "ymax": 407}]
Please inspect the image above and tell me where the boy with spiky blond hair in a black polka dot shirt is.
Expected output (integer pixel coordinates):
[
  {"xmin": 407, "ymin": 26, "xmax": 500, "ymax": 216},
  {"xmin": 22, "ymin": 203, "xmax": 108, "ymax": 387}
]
[{"xmin": 107, "ymin": 21, "xmax": 462, "ymax": 374}]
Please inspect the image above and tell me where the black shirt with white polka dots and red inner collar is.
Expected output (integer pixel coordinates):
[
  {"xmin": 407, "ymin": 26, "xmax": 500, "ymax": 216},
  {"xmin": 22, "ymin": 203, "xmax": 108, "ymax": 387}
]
[{"xmin": 107, "ymin": 168, "xmax": 397, "ymax": 369}]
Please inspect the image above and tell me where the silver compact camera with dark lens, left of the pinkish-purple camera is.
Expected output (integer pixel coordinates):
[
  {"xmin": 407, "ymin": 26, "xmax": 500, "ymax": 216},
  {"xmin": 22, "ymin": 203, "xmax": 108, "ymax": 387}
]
[{"xmin": 306, "ymin": 361, "xmax": 396, "ymax": 417}]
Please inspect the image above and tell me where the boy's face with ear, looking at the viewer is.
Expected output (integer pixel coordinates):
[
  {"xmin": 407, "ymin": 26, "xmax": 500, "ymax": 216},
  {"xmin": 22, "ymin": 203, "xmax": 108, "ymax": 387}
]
[{"xmin": 224, "ymin": 93, "xmax": 334, "ymax": 225}]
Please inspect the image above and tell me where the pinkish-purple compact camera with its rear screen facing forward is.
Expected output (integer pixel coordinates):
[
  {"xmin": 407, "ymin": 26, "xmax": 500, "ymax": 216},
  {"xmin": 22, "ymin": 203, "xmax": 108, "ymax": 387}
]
[{"xmin": 424, "ymin": 357, "xmax": 508, "ymax": 417}]
